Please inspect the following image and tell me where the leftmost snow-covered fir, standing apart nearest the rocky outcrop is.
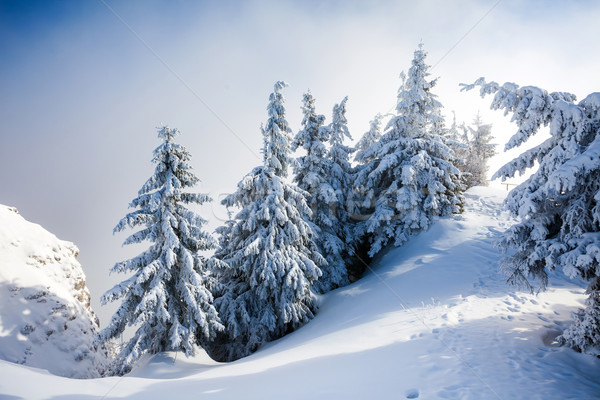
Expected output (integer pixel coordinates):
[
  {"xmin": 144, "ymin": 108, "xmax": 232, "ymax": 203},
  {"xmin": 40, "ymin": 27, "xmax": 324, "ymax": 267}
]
[{"xmin": 97, "ymin": 126, "xmax": 223, "ymax": 373}]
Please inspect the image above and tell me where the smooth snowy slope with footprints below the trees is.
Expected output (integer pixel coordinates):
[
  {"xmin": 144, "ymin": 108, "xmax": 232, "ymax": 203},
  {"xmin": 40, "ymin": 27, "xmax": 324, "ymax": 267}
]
[{"xmin": 0, "ymin": 188, "xmax": 600, "ymax": 400}]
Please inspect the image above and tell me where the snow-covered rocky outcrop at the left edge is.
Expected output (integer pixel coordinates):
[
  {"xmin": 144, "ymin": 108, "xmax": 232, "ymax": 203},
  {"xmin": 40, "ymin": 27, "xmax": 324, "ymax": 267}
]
[{"xmin": 0, "ymin": 205, "xmax": 106, "ymax": 378}]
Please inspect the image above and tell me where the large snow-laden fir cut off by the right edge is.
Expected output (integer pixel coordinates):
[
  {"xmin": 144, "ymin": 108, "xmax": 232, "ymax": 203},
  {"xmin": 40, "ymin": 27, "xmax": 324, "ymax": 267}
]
[{"xmin": 463, "ymin": 78, "xmax": 600, "ymax": 355}]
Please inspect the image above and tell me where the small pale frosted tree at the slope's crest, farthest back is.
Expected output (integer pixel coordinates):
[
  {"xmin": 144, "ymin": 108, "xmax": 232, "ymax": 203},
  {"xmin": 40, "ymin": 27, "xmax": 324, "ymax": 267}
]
[{"xmin": 465, "ymin": 113, "xmax": 496, "ymax": 188}]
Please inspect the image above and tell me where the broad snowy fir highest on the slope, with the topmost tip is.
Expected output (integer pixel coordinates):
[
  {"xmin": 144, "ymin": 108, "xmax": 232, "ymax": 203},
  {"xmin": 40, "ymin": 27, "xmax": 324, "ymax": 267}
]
[{"xmin": 356, "ymin": 44, "xmax": 463, "ymax": 256}]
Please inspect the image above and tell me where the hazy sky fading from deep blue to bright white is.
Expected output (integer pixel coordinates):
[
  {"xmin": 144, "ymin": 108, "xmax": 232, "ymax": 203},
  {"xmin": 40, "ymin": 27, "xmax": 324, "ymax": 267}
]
[{"xmin": 0, "ymin": 0, "xmax": 600, "ymax": 326}]
